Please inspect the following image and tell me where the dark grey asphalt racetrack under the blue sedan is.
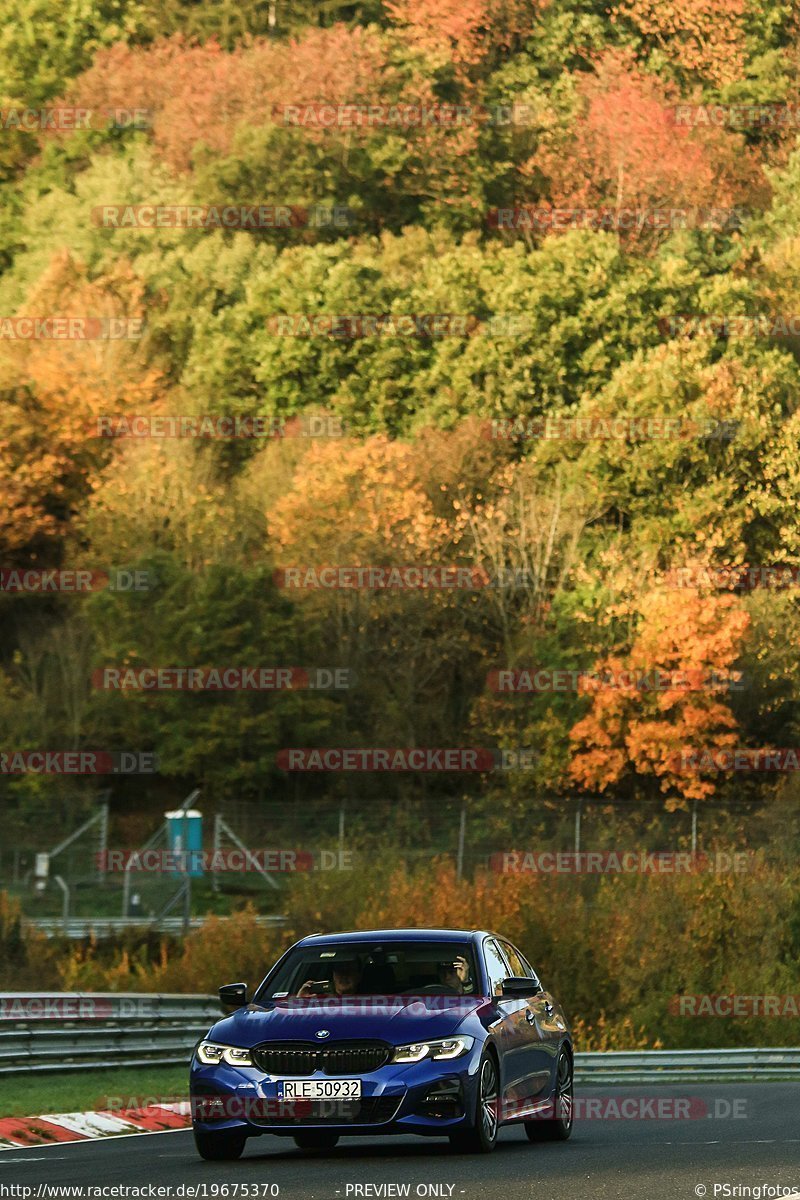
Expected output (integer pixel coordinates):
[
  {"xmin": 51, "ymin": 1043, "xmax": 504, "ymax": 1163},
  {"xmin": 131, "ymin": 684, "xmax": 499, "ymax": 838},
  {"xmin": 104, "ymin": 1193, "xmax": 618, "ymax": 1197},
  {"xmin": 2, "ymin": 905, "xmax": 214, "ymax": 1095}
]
[{"xmin": 0, "ymin": 1082, "xmax": 800, "ymax": 1200}]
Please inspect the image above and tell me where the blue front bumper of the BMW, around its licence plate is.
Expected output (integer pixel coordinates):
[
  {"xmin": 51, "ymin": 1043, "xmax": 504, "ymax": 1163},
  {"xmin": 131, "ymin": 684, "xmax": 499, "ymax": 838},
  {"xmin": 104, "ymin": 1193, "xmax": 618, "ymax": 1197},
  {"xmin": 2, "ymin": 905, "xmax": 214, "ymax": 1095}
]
[{"xmin": 190, "ymin": 1043, "xmax": 482, "ymax": 1136}]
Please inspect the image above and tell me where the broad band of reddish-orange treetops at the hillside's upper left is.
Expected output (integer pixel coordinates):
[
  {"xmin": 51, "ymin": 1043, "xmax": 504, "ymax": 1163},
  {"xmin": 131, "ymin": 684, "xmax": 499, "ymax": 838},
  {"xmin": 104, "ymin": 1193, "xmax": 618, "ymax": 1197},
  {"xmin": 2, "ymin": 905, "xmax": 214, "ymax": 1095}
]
[{"xmin": 64, "ymin": 25, "xmax": 489, "ymax": 208}]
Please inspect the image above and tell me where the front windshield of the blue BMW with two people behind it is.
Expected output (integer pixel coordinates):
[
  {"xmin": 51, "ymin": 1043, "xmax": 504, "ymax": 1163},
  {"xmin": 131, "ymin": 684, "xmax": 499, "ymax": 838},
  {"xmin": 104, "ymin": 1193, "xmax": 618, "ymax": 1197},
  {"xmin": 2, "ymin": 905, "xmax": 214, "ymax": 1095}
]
[{"xmin": 257, "ymin": 941, "xmax": 477, "ymax": 1002}]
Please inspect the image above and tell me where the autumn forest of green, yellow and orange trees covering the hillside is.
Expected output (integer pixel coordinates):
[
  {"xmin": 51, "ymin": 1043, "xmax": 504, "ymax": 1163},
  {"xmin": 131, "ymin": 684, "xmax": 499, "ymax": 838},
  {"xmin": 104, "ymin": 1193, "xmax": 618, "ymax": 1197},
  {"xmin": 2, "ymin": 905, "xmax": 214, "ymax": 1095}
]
[{"xmin": 0, "ymin": 0, "xmax": 800, "ymax": 873}]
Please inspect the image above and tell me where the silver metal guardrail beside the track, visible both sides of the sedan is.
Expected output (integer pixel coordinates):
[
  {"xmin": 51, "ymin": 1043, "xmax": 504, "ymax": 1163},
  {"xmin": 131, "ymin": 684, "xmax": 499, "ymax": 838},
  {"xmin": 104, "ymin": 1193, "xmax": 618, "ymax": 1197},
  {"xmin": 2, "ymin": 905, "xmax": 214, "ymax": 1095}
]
[{"xmin": 0, "ymin": 992, "xmax": 800, "ymax": 1087}]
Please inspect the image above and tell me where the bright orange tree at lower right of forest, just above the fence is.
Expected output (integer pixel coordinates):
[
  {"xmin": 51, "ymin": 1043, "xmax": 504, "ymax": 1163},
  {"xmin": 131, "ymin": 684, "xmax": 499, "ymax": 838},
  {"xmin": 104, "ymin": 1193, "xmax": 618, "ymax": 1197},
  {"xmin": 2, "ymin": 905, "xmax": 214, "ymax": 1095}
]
[{"xmin": 570, "ymin": 589, "xmax": 750, "ymax": 810}]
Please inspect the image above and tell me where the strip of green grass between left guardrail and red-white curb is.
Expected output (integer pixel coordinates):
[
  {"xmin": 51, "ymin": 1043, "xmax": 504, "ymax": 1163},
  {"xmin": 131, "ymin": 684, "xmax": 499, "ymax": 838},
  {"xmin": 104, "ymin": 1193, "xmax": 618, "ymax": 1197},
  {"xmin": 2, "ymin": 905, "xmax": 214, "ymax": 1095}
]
[{"xmin": 0, "ymin": 1063, "xmax": 188, "ymax": 1117}]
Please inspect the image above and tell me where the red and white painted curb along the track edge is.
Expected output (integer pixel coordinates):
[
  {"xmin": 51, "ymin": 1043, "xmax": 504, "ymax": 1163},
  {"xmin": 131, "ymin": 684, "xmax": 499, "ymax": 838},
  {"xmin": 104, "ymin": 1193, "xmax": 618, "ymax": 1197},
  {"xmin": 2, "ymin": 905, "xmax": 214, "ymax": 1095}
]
[{"xmin": 0, "ymin": 1100, "xmax": 192, "ymax": 1150}]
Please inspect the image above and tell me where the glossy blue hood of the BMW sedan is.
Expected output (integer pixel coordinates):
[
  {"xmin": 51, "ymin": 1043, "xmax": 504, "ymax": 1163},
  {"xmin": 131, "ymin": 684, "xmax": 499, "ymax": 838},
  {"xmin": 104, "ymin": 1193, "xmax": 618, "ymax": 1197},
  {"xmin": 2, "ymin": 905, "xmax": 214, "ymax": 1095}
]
[{"xmin": 209, "ymin": 996, "xmax": 487, "ymax": 1046}]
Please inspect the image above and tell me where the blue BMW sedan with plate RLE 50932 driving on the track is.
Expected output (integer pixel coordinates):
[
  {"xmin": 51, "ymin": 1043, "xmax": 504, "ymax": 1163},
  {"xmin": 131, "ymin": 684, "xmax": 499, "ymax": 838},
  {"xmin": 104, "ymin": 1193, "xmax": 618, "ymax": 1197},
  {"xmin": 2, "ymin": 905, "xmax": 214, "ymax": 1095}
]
[{"xmin": 190, "ymin": 929, "xmax": 573, "ymax": 1159}]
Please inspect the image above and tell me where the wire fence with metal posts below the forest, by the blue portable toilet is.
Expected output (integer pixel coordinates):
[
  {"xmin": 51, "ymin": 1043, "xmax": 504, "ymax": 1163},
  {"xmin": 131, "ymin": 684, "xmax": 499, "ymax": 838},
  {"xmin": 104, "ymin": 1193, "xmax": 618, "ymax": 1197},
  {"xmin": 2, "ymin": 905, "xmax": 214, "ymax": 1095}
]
[{"xmin": 0, "ymin": 792, "xmax": 790, "ymax": 931}]
